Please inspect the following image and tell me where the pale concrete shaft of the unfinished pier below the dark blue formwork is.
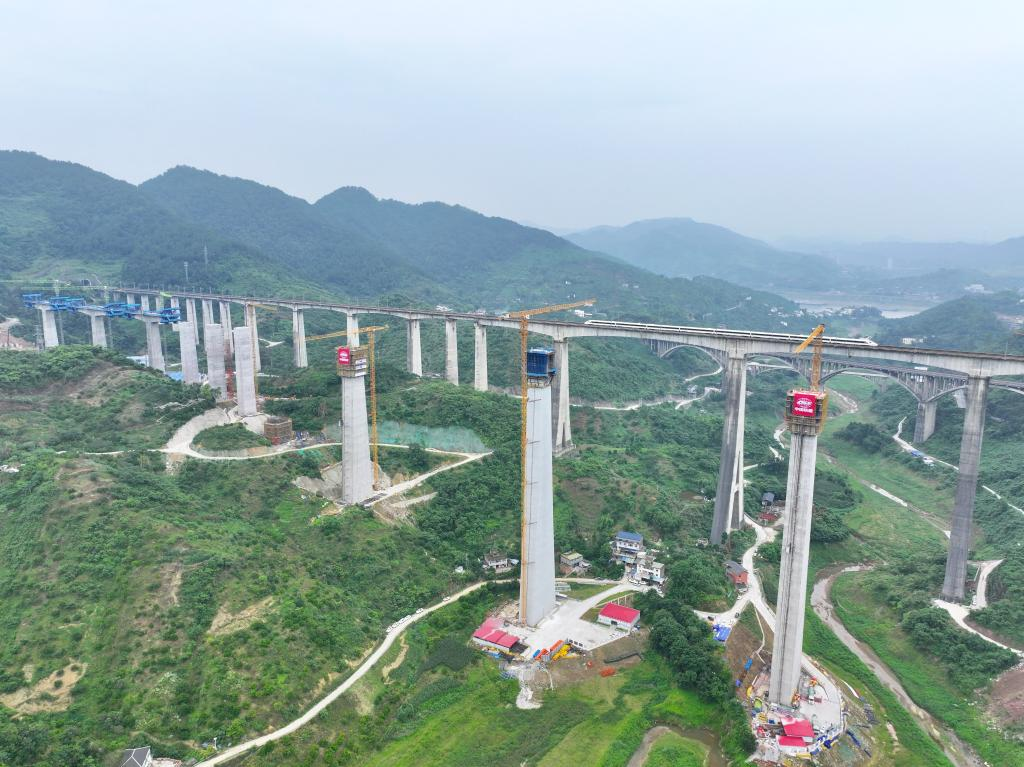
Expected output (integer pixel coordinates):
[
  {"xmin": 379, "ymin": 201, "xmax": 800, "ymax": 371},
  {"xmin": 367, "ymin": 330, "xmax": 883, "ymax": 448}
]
[{"xmin": 519, "ymin": 380, "xmax": 560, "ymax": 626}]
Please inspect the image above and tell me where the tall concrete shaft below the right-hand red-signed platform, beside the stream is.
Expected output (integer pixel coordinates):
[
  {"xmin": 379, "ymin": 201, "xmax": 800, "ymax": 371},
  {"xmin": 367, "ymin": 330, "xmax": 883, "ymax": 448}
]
[{"xmin": 768, "ymin": 425, "xmax": 818, "ymax": 706}]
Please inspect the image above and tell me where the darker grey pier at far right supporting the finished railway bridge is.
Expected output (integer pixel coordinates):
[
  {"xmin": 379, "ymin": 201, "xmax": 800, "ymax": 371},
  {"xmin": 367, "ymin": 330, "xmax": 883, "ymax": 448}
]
[{"xmin": 942, "ymin": 377, "xmax": 989, "ymax": 601}]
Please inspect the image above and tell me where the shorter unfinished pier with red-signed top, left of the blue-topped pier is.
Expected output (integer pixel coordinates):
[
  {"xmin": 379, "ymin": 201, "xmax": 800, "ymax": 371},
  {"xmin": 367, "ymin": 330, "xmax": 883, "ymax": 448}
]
[{"xmin": 338, "ymin": 346, "xmax": 374, "ymax": 504}]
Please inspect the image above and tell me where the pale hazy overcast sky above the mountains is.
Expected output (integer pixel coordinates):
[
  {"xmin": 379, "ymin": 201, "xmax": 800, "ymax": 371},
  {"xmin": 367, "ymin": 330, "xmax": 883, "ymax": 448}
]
[{"xmin": 0, "ymin": 0, "xmax": 1024, "ymax": 240}]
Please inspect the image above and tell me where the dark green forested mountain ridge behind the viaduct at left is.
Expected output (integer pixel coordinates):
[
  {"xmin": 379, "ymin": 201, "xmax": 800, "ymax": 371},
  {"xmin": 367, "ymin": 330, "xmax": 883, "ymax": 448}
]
[{"xmin": 0, "ymin": 152, "xmax": 806, "ymax": 328}]
